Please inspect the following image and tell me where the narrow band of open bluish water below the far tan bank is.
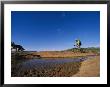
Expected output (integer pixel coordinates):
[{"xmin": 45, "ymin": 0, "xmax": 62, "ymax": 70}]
[{"xmin": 18, "ymin": 55, "xmax": 94, "ymax": 69}]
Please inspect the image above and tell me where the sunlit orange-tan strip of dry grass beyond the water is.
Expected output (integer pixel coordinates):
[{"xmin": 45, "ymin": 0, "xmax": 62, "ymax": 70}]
[{"xmin": 33, "ymin": 51, "xmax": 94, "ymax": 58}]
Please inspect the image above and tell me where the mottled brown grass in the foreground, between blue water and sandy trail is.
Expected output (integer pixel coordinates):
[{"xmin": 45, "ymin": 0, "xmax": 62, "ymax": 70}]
[{"xmin": 11, "ymin": 62, "xmax": 81, "ymax": 77}]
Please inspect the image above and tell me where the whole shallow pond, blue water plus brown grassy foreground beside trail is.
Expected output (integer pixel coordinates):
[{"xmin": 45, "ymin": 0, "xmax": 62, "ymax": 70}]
[{"xmin": 11, "ymin": 55, "xmax": 95, "ymax": 77}]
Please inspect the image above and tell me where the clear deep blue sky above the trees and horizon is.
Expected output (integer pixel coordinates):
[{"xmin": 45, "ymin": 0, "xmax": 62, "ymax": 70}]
[{"xmin": 11, "ymin": 11, "xmax": 100, "ymax": 51}]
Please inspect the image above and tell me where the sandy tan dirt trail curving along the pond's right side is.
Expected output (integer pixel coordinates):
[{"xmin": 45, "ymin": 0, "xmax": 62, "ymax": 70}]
[{"xmin": 73, "ymin": 56, "xmax": 100, "ymax": 77}]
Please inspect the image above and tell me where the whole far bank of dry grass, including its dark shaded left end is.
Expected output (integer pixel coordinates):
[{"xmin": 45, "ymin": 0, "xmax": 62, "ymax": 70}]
[{"xmin": 11, "ymin": 51, "xmax": 96, "ymax": 59}]
